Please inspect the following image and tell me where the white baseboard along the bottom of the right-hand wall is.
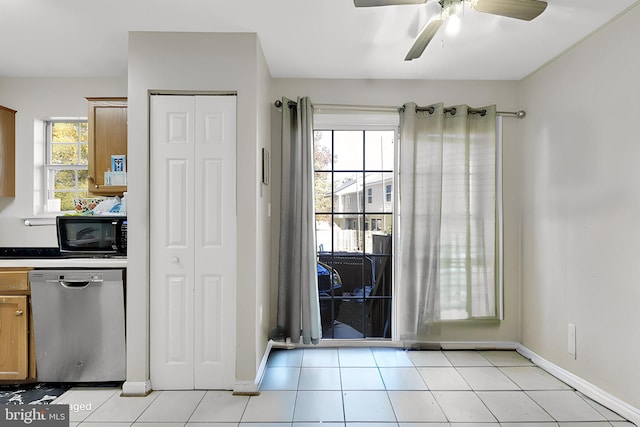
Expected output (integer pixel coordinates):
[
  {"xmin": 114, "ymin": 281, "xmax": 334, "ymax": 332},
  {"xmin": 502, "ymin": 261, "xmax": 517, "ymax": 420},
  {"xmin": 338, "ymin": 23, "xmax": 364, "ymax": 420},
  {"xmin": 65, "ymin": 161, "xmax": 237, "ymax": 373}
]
[{"xmin": 516, "ymin": 344, "xmax": 640, "ymax": 425}]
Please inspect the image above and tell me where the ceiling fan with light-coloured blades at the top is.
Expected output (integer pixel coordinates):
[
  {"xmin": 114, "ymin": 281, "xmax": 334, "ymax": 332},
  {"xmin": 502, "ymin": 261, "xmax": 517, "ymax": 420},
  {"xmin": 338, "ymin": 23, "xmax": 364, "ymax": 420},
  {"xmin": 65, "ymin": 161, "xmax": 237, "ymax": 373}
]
[{"xmin": 353, "ymin": 0, "xmax": 547, "ymax": 61}]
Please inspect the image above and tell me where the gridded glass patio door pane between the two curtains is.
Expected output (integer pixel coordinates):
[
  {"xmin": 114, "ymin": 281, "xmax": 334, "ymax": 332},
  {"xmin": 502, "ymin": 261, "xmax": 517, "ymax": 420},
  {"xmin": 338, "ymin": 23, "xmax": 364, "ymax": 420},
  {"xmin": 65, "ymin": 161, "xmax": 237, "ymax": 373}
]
[{"xmin": 314, "ymin": 128, "xmax": 396, "ymax": 338}]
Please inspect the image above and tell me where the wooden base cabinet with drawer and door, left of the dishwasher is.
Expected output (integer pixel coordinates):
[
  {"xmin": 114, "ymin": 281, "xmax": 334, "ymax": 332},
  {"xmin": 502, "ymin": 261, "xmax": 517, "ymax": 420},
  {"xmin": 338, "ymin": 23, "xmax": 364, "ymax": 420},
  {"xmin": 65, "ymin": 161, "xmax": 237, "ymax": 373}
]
[{"xmin": 0, "ymin": 268, "xmax": 35, "ymax": 380}]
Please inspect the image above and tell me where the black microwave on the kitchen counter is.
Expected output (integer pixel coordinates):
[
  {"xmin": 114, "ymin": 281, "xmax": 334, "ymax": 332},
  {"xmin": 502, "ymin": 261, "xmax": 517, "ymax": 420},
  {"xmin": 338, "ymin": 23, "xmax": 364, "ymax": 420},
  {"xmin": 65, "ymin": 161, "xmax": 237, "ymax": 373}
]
[{"xmin": 56, "ymin": 215, "xmax": 127, "ymax": 256}]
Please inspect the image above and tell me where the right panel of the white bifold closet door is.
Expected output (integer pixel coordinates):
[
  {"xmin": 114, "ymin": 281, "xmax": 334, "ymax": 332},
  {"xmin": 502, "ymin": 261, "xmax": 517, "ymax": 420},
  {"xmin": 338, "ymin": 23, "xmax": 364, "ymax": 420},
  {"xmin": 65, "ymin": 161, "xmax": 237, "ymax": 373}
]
[{"xmin": 193, "ymin": 96, "xmax": 236, "ymax": 389}]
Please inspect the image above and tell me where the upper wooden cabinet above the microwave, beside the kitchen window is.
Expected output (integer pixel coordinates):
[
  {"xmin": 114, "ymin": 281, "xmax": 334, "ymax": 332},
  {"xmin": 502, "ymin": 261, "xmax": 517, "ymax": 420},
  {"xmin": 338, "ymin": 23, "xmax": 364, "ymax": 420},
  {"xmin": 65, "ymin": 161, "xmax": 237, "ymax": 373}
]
[{"xmin": 87, "ymin": 98, "xmax": 127, "ymax": 196}]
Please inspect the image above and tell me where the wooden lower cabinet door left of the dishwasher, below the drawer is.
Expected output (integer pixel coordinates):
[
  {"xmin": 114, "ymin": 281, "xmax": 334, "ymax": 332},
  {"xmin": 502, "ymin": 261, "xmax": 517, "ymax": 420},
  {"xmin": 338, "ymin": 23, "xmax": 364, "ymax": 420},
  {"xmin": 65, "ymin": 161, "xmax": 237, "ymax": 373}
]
[{"xmin": 0, "ymin": 295, "xmax": 29, "ymax": 380}]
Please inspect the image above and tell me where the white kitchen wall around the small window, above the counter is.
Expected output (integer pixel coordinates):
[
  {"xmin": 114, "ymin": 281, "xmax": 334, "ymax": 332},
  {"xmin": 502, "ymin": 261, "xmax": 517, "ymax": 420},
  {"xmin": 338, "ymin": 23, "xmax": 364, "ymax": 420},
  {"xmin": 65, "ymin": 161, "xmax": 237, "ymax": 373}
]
[{"xmin": 0, "ymin": 78, "xmax": 127, "ymax": 247}]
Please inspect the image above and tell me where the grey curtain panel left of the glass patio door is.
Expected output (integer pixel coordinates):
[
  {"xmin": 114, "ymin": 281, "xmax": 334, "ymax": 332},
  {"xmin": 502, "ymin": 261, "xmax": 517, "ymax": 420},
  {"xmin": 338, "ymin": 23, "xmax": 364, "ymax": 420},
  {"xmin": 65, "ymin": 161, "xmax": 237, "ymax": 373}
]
[{"xmin": 277, "ymin": 97, "xmax": 322, "ymax": 344}]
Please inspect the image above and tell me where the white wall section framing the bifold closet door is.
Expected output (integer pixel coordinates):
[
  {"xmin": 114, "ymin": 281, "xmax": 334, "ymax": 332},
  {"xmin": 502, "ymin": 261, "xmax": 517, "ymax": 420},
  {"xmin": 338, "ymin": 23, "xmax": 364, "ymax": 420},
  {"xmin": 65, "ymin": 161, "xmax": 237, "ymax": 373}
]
[{"xmin": 125, "ymin": 32, "xmax": 270, "ymax": 390}]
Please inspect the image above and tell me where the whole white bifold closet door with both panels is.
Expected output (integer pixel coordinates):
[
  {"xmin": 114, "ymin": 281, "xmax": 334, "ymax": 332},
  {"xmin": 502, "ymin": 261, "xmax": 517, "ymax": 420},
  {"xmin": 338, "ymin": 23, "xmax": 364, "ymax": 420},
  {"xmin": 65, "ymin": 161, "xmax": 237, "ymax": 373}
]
[{"xmin": 149, "ymin": 95, "xmax": 237, "ymax": 390}]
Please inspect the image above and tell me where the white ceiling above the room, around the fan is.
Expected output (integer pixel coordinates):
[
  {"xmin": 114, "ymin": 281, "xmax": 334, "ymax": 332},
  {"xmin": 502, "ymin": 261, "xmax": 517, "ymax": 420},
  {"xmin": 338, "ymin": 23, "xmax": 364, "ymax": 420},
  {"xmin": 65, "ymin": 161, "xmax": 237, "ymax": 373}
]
[{"xmin": 0, "ymin": 0, "xmax": 640, "ymax": 80}]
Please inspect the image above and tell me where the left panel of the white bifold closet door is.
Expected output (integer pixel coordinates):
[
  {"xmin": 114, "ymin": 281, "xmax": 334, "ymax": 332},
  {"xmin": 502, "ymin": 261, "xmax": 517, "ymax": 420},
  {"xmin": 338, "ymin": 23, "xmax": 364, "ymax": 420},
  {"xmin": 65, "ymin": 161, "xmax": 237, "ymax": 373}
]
[{"xmin": 149, "ymin": 96, "xmax": 195, "ymax": 390}]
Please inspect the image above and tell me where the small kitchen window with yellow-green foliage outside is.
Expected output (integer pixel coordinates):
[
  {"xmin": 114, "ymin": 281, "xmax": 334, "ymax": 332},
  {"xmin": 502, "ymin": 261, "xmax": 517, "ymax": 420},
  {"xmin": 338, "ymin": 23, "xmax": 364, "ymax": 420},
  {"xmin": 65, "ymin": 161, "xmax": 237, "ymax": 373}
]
[{"xmin": 45, "ymin": 119, "xmax": 89, "ymax": 211}]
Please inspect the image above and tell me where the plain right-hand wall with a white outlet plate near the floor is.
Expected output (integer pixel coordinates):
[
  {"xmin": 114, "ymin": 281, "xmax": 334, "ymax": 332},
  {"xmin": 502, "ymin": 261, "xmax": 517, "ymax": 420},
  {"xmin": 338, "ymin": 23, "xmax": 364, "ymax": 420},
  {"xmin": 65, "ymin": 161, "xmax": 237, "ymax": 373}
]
[{"xmin": 514, "ymin": 7, "xmax": 640, "ymax": 408}]
